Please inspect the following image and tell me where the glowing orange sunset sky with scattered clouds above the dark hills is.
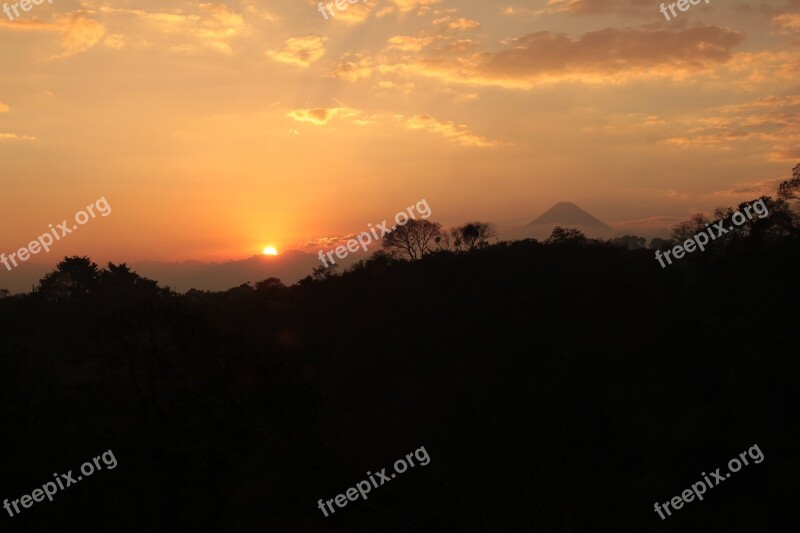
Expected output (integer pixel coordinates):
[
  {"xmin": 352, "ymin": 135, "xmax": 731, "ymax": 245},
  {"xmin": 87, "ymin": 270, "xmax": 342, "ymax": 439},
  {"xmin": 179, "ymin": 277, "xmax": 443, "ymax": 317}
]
[{"xmin": 0, "ymin": 0, "xmax": 800, "ymax": 264}]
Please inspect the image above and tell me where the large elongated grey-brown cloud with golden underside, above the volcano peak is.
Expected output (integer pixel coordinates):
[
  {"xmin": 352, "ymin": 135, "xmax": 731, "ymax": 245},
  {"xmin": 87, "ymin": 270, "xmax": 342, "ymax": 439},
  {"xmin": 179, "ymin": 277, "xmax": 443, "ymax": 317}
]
[{"xmin": 383, "ymin": 26, "xmax": 744, "ymax": 89}]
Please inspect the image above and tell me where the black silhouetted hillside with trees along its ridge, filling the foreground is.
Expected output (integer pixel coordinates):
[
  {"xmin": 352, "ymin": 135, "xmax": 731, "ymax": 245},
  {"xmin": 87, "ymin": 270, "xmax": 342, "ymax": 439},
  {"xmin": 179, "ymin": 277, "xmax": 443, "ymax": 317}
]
[{"xmin": 0, "ymin": 185, "xmax": 800, "ymax": 533}]
